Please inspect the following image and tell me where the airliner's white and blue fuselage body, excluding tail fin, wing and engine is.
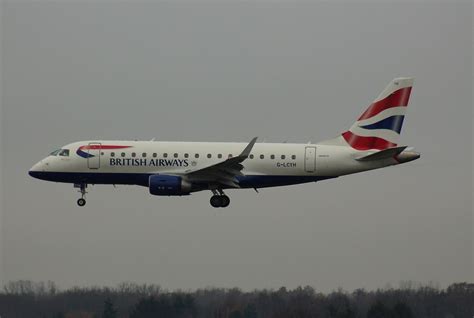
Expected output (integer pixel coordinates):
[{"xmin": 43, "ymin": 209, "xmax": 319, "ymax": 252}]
[{"xmin": 30, "ymin": 140, "xmax": 398, "ymax": 190}]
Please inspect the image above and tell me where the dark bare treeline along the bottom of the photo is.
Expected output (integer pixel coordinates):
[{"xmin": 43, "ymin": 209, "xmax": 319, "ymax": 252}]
[{"xmin": 0, "ymin": 281, "xmax": 474, "ymax": 318}]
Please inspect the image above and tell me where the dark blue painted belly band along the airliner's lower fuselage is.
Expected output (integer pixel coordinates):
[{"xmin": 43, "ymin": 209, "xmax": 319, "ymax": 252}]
[{"xmin": 29, "ymin": 171, "xmax": 336, "ymax": 188}]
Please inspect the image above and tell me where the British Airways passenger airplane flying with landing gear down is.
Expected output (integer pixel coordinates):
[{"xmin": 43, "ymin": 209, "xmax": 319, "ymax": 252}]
[{"xmin": 29, "ymin": 77, "xmax": 420, "ymax": 208}]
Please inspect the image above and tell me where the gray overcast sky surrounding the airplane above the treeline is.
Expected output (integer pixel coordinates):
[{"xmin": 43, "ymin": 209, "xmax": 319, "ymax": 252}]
[{"xmin": 0, "ymin": 1, "xmax": 474, "ymax": 291}]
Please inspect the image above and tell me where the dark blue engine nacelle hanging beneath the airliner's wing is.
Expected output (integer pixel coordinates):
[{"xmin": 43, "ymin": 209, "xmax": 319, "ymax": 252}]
[{"xmin": 148, "ymin": 174, "xmax": 191, "ymax": 195}]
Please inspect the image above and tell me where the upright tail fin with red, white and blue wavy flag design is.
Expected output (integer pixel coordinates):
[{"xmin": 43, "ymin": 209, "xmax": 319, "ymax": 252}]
[{"xmin": 342, "ymin": 77, "xmax": 413, "ymax": 150}]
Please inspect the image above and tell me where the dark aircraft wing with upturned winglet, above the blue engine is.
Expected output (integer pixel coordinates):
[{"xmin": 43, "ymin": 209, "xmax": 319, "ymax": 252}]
[{"xmin": 185, "ymin": 137, "xmax": 257, "ymax": 188}]
